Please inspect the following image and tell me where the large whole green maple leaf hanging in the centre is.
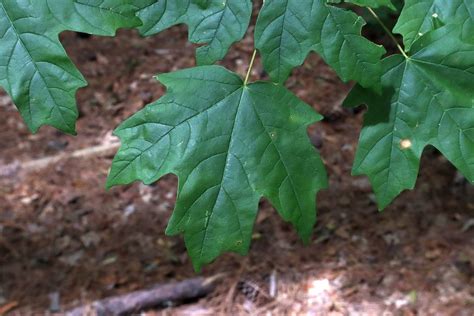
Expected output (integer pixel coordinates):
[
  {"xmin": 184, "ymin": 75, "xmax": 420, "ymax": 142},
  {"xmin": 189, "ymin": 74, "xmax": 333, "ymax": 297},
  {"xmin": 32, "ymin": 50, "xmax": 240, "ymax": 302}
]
[{"xmin": 107, "ymin": 66, "xmax": 326, "ymax": 270}]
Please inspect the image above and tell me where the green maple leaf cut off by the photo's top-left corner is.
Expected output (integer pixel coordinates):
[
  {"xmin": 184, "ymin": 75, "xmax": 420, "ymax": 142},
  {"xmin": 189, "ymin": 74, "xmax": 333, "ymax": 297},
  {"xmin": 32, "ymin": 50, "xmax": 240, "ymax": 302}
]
[{"xmin": 0, "ymin": 0, "xmax": 140, "ymax": 134}]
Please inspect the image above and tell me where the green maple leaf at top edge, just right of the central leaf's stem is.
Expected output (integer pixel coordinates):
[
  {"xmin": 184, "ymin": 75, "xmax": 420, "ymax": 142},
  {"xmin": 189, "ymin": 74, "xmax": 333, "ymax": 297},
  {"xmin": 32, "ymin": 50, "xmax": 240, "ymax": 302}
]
[{"xmin": 255, "ymin": 0, "xmax": 385, "ymax": 87}]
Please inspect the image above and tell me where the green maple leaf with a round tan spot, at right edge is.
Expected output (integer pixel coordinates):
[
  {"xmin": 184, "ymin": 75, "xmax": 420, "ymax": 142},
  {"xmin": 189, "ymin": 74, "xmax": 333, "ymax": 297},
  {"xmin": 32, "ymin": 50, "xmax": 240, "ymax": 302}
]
[{"xmin": 346, "ymin": 25, "xmax": 474, "ymax": 209}]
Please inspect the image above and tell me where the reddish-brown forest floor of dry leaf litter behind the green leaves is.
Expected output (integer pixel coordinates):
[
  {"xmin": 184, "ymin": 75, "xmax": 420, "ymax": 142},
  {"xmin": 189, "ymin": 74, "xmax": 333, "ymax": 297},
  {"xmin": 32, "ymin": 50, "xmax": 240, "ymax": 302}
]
[{"xmin": 0, "ymin": 22, "xmax": 474, "ymax": 315}]
